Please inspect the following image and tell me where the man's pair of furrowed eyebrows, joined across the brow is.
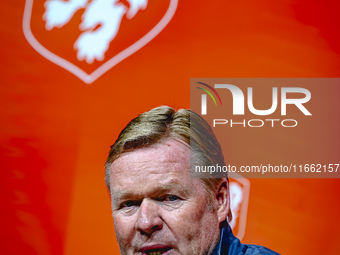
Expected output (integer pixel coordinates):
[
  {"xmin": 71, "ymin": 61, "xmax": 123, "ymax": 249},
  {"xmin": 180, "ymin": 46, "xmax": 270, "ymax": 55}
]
[{"xmin": 111, "ymin": 179, "xmax": 189, "ymax": 202}]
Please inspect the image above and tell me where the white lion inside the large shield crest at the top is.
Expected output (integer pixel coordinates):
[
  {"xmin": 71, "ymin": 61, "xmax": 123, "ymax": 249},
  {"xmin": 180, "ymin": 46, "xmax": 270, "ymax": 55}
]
[{"xmin": 42, "ymin": 0, "xmax": 148, "ymax": 64}]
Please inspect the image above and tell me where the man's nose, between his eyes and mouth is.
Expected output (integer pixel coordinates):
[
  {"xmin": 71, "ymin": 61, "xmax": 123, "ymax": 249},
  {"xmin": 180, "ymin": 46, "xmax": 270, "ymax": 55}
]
[{"xmin": 136, "ymin": 199, "xmax": 163, "ymax": 236}]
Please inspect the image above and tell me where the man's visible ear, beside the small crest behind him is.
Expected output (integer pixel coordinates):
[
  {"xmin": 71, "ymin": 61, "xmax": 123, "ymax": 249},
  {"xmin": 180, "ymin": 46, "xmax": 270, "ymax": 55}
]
[{"xmin": 216, "ymin": 178, "xmax": 229, "ymax": 225}]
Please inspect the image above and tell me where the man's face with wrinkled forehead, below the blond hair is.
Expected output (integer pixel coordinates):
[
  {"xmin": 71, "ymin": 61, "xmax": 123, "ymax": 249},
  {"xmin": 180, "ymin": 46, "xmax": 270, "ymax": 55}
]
[{"xmin": 110, "ymin": 141, "xmax": 219, "ymax": 255}]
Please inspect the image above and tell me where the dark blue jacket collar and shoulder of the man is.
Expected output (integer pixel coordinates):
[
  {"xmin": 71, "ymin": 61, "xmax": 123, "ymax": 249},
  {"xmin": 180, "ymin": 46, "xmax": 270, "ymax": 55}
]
[{"xmin": 212, "ymin": 224, "xmax": 279, "ymax": 255}]
